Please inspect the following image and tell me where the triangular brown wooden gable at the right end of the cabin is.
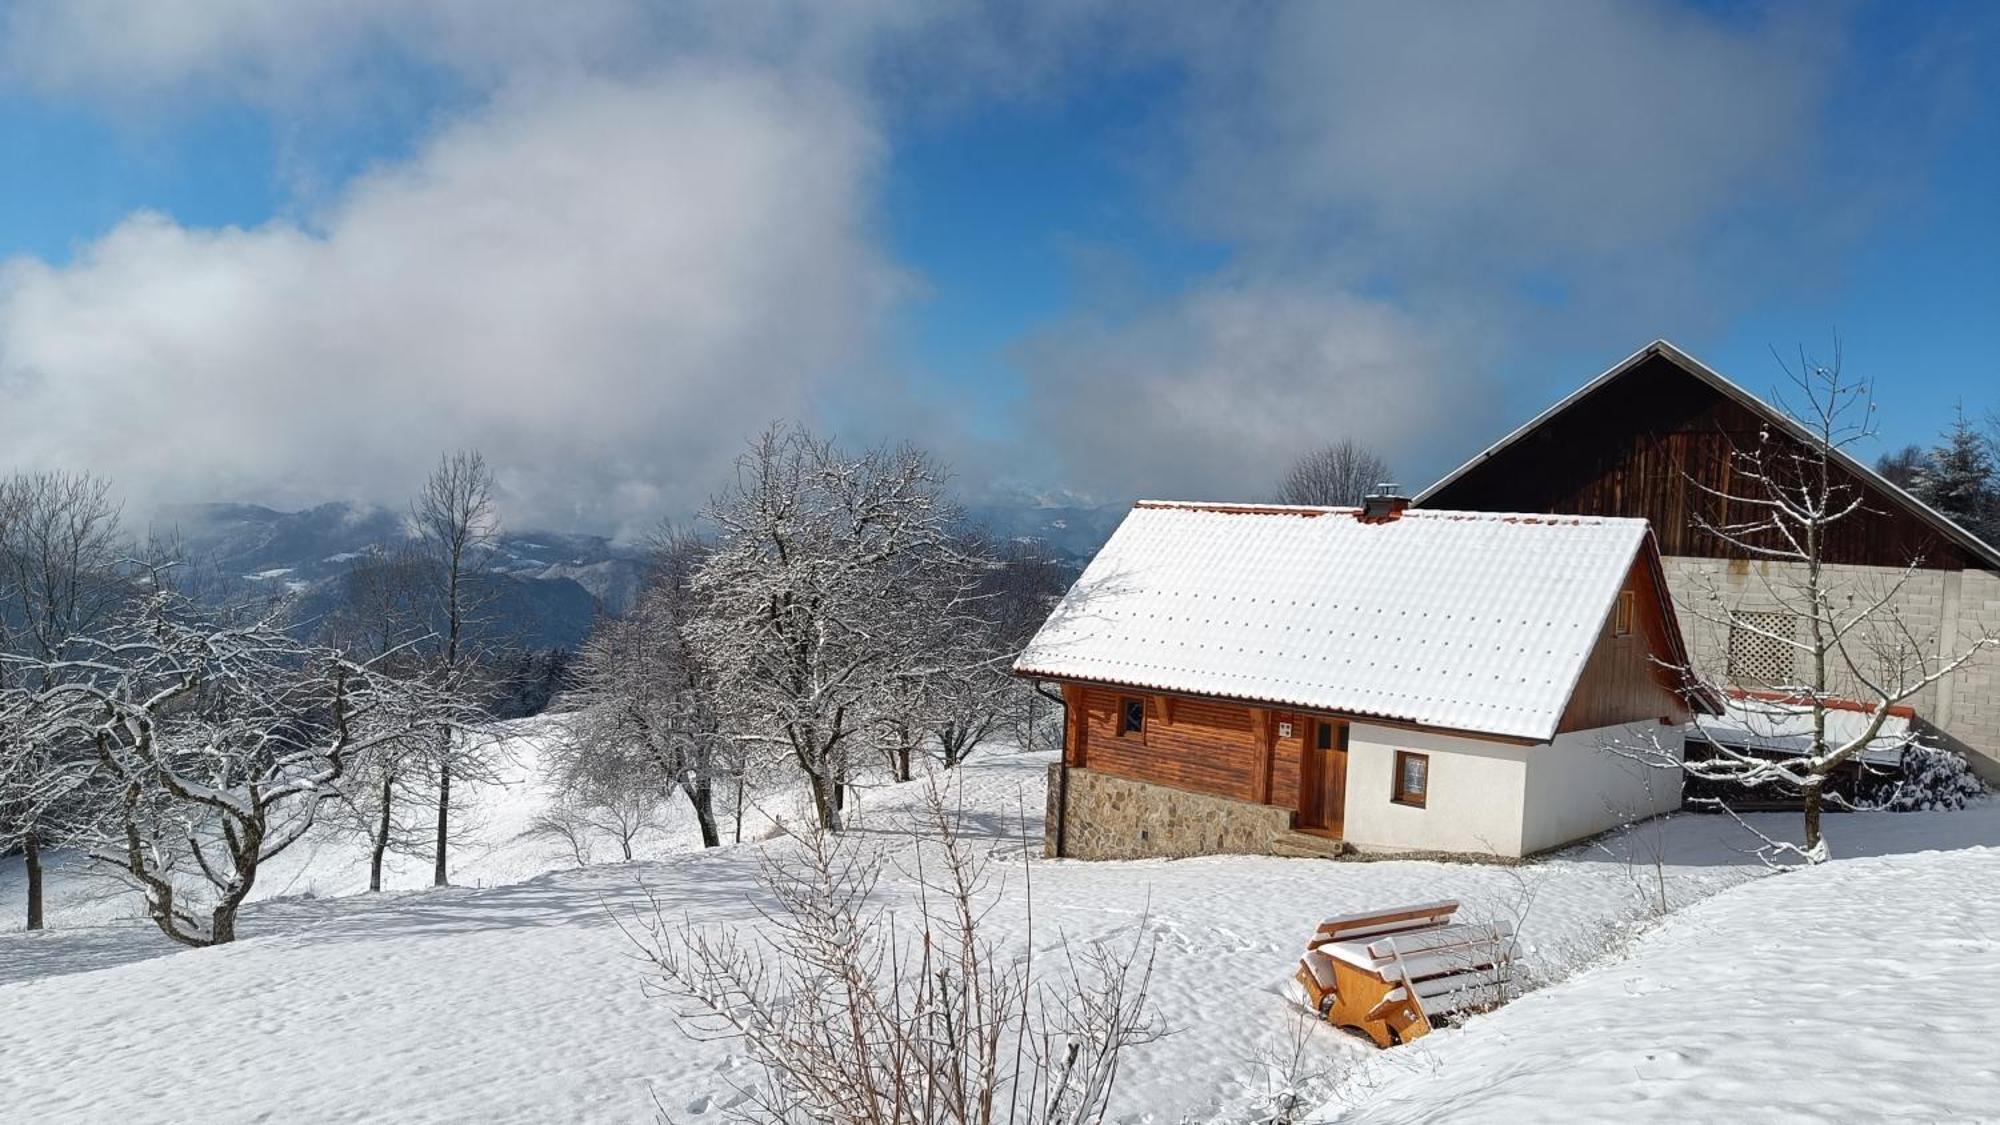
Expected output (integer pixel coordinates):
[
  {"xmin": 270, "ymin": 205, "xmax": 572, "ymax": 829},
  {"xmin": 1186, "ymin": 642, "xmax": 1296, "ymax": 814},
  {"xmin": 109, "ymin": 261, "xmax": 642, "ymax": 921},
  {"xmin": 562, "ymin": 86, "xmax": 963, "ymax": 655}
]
[{"xmin": 1558, "ymin": 554, "xmax": 1690, "ymax": 731}]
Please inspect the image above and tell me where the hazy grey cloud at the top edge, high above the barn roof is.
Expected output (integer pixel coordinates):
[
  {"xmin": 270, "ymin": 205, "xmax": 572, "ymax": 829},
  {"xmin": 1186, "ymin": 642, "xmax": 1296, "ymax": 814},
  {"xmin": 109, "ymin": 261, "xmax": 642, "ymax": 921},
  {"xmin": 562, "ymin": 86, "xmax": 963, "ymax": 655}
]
[{"xmin": 1190, "ymin": 2, "xmax": 1838, "ymax": 264}]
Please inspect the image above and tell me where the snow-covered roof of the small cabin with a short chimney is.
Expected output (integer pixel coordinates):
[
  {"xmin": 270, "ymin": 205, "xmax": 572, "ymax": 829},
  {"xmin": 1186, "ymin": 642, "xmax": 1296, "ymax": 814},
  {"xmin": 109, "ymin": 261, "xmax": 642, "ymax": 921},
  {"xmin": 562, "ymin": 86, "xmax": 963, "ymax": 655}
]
[{"xmin": 1014, "ymin": 500, "xmax": 1650, "ymax": 741}]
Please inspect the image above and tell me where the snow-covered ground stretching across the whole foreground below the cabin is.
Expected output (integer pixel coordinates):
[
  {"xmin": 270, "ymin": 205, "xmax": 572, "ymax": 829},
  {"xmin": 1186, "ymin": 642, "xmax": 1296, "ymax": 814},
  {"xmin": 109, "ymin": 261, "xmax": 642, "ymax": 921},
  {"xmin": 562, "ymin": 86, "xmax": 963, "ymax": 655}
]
[{"xmin": 0, "ymin": 721, "xmax": 2000, "ymax": 1123}]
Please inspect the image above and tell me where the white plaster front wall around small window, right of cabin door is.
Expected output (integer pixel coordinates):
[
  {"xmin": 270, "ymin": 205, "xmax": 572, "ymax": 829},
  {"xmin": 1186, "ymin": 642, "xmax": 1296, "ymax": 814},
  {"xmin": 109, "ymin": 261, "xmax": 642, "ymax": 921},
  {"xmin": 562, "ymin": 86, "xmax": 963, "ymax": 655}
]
[{"xmin": 1340, "ymin": 723, "xmax": 1544, "ymax": 857}]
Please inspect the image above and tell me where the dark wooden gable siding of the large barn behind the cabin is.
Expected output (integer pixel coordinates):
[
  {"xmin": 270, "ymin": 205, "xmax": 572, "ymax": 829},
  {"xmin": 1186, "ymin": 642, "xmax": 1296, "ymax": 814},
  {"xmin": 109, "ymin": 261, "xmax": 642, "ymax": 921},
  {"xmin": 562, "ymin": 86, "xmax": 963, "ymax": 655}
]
[{"xmin": 1424, "ymin": 356, "xmax": 1966, "ymax": 571}]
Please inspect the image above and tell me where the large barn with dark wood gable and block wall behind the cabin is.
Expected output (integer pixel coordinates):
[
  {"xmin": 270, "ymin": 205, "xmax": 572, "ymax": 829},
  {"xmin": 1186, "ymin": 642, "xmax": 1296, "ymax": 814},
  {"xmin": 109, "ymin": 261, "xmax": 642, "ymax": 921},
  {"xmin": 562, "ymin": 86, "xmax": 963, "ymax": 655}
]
[{"xmin": 1416, "ymin": 340, "xmax": 2000, "ymax": 781}]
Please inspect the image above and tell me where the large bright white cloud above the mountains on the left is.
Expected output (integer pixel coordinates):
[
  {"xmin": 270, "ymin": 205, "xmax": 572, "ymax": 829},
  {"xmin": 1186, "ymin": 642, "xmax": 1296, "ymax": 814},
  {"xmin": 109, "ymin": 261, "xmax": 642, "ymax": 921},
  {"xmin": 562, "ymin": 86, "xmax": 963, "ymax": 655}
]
[{"xmin": 0, "ymin": 68, "xmax": 898, "ymax": 526}]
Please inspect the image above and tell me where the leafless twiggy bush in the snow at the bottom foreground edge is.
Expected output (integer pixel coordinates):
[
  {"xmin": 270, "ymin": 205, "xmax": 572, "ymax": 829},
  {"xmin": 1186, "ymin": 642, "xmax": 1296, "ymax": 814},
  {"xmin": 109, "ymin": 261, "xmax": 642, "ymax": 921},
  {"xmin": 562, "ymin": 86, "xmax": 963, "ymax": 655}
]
[{"xmin": 620, "ymin": 768, "xmax": 1164, "ymax": 1125}]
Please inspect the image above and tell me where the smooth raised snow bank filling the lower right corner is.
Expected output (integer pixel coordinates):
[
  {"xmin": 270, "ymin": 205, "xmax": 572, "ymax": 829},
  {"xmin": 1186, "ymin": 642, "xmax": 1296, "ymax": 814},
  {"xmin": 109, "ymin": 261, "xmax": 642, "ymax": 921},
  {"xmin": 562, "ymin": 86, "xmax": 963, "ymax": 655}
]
[{"xmin": 1320, "ymin": 832, "xmax": 2000, "ymax": 1123}]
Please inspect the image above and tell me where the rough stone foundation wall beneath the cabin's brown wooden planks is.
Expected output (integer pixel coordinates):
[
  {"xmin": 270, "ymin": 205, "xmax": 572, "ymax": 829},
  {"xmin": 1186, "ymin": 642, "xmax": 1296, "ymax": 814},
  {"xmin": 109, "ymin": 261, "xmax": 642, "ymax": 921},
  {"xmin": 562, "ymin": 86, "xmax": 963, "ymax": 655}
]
[{"xmin": 1044, "ymin": 763, "xmax": 1292, "ymax": 859}]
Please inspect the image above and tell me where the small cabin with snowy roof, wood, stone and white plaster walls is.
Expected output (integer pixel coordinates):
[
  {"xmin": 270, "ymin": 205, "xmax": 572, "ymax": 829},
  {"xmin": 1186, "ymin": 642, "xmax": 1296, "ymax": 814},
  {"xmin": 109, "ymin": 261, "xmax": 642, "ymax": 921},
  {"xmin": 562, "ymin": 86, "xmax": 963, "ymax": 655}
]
[{"xmin": 1014, "ymin": 498, "xmax": 1714, "ymax": 859}]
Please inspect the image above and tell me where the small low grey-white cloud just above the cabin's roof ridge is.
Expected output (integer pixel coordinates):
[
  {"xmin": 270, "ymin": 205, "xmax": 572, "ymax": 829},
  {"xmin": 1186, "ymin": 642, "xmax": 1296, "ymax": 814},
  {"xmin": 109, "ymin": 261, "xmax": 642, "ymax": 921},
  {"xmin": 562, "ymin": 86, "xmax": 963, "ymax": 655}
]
[{"xmin": 1028, "ymin": 282, "xmax": 1488, "ymax": 500}]
